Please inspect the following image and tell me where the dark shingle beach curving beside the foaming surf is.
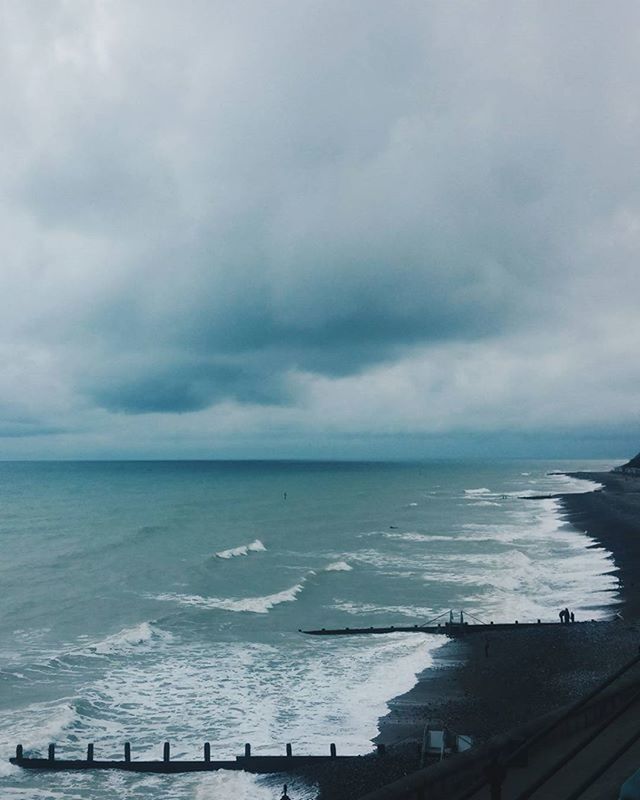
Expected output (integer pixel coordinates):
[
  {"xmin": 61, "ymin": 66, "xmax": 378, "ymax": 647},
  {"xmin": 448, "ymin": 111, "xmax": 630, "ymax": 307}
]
[{"xmin": 302, "ymin": 466, "xmax": 640, "ymax": 800}]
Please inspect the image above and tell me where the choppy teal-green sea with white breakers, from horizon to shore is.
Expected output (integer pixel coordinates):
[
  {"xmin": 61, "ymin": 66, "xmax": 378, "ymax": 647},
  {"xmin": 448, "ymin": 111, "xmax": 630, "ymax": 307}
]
[{"xmin": 0, "ymin": 460, "xmax": 618, "ymax": 800}]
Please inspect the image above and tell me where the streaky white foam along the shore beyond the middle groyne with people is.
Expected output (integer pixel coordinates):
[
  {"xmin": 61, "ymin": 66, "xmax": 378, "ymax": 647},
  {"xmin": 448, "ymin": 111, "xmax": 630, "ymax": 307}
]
[{"xmin": 358, "ymin": 494, "xmax": 618, "ymax": 621}]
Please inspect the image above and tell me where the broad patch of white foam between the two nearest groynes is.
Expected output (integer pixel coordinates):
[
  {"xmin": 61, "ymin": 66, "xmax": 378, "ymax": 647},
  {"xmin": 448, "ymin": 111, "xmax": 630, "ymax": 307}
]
[{"xmin": 70, "ymin": 633, "xmax": 443, "ymax": 756}]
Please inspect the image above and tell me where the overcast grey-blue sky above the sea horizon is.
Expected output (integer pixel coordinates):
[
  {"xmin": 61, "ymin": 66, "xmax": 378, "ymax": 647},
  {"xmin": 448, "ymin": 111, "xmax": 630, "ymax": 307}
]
[{"xmin": 0, "ymin": 0, "xmax": 640, "ymax": 458}]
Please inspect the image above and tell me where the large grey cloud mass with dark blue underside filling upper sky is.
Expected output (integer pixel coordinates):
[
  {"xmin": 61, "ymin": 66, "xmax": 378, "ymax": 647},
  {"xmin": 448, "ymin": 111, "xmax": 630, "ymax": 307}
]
[{"xmin": 0, "ymin": 0, "xmax": 640, "ymax": 444}]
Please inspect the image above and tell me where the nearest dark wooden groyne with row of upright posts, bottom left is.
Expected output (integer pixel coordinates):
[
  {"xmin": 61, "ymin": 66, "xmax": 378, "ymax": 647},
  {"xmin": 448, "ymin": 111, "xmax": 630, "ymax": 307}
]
[{"xmin": 9, "ymin": 742, "xmax": 362, "ymax": 774}]
